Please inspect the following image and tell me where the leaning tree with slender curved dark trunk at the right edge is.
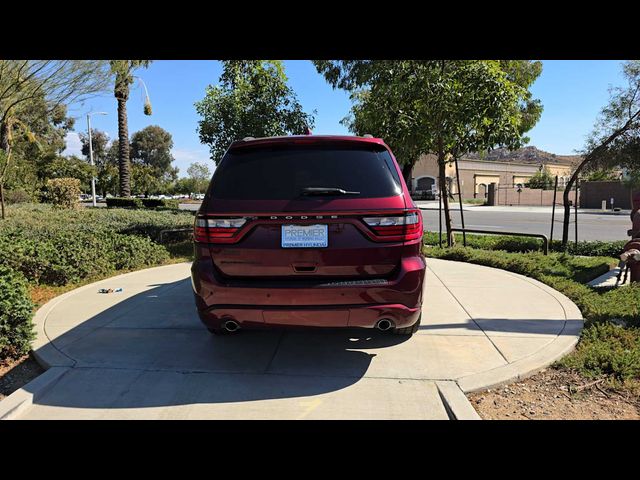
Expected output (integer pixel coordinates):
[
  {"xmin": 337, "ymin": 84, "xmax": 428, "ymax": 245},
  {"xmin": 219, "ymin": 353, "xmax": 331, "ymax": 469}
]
[{"xmin": 562, "ymin": 60, "xmax": 640, "ymax": 245}]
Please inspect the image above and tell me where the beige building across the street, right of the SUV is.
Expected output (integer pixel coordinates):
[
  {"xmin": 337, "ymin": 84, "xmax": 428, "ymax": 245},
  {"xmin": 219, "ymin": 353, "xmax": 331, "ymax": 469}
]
[{"xmin": 411, "ymin": 147, "xmax": 579, "ymax": 199}]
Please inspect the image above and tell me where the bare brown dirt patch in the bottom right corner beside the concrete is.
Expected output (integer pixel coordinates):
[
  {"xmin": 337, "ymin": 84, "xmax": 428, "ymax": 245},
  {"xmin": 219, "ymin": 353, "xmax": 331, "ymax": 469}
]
[{"xmin": 467, "ymin": 368, "xmax": 640, "ymax": 420}]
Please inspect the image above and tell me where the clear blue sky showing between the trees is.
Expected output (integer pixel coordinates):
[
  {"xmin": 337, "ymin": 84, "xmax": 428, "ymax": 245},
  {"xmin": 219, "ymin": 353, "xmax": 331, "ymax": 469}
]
[{"xmin": 64, "ymin": 60, "xmax": 623, "ymax": 176}]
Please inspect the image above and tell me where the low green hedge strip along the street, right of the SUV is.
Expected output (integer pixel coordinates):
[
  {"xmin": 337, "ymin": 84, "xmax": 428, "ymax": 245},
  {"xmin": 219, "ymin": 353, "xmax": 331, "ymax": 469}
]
[{"xmin": 424, "ymin": 232, "xmax": 627, "ymax": 257}]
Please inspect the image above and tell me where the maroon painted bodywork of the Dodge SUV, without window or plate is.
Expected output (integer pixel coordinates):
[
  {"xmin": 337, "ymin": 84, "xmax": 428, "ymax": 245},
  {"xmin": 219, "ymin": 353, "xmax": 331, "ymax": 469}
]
[{"xmin": 192, "ymin": 136, "xmax": 426, "ymax": 330}]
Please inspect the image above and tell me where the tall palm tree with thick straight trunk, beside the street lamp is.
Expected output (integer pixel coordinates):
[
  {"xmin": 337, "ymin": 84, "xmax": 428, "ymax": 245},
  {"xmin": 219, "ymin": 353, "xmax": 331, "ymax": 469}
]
[{"xmin": 110, "ymin": 60, "xmax": 151, "ymax": 197}]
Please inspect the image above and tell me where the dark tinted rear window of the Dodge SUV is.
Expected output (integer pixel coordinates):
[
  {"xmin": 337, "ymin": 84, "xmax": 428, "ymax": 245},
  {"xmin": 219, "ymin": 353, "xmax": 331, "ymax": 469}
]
[{"xmin": 210, "ymin": 145, "xmax": 402, "ymax": 200}]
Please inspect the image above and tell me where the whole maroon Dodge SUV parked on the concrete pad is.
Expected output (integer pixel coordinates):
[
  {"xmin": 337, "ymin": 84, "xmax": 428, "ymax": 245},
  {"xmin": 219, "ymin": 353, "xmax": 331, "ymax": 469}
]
[{"xmin": 191, "ymin": 135, "xmax": 425, "ymax": 335}]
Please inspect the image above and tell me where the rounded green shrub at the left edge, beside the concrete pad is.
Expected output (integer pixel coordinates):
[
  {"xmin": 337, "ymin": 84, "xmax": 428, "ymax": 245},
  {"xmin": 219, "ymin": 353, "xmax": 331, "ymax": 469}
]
[{"xmin": 0, "ymin": 265, "xmax": 34, "ymax": 358}]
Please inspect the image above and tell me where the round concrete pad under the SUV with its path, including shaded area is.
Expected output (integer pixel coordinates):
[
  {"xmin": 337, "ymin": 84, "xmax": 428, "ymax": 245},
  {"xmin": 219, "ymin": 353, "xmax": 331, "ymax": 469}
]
[{"xmin": 0, "ymin": 259, "xmax": 582, "ymax": 419}]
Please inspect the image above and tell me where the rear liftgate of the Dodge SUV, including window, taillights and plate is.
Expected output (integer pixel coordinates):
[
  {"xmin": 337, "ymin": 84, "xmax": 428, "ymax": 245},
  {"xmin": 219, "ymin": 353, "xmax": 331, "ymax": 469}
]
[{"xmin": 195, "ymin": 137, "xmax": 422, "ymax": 282}]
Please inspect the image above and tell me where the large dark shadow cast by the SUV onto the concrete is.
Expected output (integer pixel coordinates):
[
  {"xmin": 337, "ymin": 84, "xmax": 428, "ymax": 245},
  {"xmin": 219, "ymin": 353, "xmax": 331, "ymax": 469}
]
[{"xmin": 25, "ymin": 278, "xmax": 409, "ymax": 409}]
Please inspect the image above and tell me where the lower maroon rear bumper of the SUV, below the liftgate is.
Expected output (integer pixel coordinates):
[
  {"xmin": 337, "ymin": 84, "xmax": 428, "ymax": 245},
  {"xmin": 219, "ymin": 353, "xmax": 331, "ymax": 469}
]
[{"xmin": 191, "ymin": 256, "xmax": 425, "ymax": 328}]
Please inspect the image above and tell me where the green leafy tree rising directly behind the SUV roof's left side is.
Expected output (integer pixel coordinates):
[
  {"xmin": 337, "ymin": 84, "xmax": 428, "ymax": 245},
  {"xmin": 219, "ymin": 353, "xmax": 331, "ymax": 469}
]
[{"xmin": 195, "ymin": 60, "xmax": 315, "ymax": 163}]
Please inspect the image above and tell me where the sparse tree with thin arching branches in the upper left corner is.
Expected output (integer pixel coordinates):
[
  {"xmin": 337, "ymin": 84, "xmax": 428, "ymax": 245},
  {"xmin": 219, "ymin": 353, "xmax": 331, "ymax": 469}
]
[{"xmin": 0, "ymin": 60, "xmax": 108, "ymax": 218}]
